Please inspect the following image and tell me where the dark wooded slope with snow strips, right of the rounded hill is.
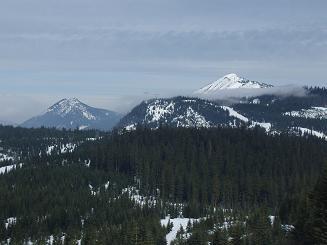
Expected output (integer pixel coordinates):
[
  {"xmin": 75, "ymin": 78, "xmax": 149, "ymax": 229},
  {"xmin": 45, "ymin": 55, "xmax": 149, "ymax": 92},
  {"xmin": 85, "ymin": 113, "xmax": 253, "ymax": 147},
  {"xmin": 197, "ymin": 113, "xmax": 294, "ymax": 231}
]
[{"xmin": 233, "ymin": 87, "xmax": 327, "ymax": 134}]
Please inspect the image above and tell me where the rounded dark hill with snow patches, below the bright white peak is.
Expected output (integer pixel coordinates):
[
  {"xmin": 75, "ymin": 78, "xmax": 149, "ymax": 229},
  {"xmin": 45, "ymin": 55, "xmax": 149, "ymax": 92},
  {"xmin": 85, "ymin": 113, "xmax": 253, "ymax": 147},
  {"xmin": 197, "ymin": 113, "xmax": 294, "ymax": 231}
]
[{"xmin": 117, "ymin": 97, "xmax": 270, "ymax": 131}]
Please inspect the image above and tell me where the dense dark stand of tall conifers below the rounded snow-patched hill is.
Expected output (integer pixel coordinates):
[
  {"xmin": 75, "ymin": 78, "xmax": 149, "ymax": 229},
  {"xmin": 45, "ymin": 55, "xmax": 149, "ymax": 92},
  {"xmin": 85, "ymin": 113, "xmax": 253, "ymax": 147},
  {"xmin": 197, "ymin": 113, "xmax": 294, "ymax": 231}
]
[{"xmin": 75, "ymin": 128, "xmax": 327, "ymax": 215}]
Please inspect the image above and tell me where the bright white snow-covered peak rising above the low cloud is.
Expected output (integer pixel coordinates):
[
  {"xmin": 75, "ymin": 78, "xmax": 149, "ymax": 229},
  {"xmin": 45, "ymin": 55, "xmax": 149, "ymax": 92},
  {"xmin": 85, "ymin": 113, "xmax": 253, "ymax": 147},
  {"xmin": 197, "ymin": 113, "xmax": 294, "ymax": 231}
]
[{"xmin": 195, "ymin": 73, "xmax": 273, "ymax": 95}]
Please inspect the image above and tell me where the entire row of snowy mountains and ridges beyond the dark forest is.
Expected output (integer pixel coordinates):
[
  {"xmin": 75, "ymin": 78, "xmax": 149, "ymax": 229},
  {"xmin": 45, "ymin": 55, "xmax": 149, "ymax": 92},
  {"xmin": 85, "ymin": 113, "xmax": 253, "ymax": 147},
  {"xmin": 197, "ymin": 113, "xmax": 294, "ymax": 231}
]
[{"xmin": 21, "ymin": 74, "xmax": 327, "ymax": 139}]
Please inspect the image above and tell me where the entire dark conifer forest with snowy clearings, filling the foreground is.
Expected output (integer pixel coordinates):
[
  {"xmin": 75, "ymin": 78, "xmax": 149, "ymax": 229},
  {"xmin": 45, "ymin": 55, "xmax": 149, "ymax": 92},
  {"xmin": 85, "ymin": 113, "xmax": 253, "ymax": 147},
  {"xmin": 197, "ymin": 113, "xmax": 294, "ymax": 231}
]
[{"xmin": 0, "ymin": 127, "xmax": 327, "ymax": 245}]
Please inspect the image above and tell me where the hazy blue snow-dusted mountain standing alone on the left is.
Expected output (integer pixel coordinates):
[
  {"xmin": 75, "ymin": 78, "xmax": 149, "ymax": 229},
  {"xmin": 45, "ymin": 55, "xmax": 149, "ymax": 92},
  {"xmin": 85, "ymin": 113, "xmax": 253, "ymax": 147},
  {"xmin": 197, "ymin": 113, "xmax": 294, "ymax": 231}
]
[{"xmin": 20, "ymin": 98, "xmax": 121, "ymax": 130}]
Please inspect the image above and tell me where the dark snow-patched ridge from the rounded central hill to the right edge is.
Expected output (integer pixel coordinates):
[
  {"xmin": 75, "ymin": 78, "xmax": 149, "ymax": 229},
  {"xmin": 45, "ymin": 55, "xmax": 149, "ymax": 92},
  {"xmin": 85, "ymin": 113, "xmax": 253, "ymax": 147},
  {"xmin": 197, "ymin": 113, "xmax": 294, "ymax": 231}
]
[{"xmin": 117, "ymin": 88, "xmax": 327, "ymax": 139}]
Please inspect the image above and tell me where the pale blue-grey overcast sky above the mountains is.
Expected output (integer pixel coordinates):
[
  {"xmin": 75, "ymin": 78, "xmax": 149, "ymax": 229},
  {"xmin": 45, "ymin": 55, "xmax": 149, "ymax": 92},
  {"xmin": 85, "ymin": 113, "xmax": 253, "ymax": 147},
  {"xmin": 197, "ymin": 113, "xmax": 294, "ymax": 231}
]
[{"xmin": 0, "ymin": 0, "xmax": 327, "ymax": 123}]
